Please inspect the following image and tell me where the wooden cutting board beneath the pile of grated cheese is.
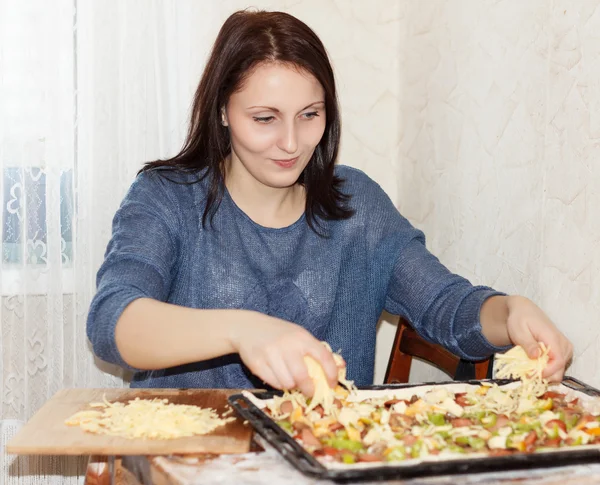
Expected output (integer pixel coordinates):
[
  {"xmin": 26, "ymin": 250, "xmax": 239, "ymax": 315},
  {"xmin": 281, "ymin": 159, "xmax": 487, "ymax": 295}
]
[{"xmin": 6, "ymin": 389, "xmax": 252, "ymax": 455}]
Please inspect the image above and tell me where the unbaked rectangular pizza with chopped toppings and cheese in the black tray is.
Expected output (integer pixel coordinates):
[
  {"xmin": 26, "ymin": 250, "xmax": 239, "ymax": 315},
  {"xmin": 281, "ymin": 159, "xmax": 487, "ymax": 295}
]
[{"xmin": 248, "ymin": 348, "xmax": 600, "ymax": 465}]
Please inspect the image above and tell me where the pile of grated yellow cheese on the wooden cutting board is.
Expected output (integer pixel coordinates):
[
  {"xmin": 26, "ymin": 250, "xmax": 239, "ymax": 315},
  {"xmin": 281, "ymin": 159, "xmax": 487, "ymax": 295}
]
[{"xmin": 65, "ymin": 398, "xmax": 235, "ymax": 440}]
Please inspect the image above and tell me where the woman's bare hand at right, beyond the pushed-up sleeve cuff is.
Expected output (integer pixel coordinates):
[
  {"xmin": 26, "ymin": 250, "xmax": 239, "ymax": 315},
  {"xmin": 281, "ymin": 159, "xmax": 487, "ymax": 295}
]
[{"xmin": 506, "ymin": 296, "xmax": 573, "ymax": 382}]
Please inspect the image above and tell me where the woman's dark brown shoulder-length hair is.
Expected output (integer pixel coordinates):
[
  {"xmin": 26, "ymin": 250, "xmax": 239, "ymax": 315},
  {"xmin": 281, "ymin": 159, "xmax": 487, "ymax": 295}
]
[{"xmin": 141, "ymin": 11, "xmax": 354, "ymax": 235}]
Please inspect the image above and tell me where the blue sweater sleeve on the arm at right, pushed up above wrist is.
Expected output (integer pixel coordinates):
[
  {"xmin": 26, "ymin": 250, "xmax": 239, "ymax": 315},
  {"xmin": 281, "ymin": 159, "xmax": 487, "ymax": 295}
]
[{"xmin": 346, "ymin": 168, "xmax": 509, "ymax": 360}]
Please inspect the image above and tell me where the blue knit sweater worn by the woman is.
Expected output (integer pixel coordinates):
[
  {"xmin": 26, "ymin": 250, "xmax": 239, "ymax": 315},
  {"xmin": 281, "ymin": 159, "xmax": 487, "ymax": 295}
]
[{"xmin": 87, "ymin": 166, "xmax": 506, "ymax": 388}]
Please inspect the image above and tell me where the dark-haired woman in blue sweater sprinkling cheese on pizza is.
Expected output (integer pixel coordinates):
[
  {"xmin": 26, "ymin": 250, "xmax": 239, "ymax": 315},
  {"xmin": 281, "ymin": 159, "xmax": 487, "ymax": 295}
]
[{"xmin": 87, "ymin": 12, "xmax": 572, "ymax": 395}]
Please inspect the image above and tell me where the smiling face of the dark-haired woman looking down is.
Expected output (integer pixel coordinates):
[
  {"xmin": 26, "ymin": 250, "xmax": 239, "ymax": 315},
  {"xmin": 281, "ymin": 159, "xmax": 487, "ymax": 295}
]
[{"xmin": 224, "ymin": 63, "xmax": 325, "ymax": 188}]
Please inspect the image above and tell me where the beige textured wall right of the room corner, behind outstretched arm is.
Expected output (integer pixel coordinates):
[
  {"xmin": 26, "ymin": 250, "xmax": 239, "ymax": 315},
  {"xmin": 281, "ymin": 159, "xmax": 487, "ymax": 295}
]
[{"xmin": 378, "ymin": 0, "xmax": 600, "ymax": 386}]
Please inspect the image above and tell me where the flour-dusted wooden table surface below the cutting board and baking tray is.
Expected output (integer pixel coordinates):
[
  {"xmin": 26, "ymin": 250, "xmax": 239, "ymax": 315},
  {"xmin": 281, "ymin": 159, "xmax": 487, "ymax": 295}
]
[{"xmin": 86, "ymin": 441, "xmax": 600, "ymax": 485}]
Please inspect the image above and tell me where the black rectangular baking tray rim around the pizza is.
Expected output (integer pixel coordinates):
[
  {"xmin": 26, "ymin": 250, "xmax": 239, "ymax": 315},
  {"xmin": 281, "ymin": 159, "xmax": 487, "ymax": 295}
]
[{"xmin": 229, "ymin": 377, "xmax": 600, "ymax": 482}]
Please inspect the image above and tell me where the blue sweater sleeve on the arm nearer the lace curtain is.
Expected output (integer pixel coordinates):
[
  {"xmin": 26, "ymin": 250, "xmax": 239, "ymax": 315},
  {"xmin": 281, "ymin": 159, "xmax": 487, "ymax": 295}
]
[{"xmin": 87, "ymin": 173, "xmax": 178, "ymax": 370}]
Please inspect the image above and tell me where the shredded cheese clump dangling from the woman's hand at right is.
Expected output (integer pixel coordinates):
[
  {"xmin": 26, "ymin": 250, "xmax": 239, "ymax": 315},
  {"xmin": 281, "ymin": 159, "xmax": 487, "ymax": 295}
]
[{"xmin": 496, "ymin": 342, "xmax": 550, "ymax": 397}]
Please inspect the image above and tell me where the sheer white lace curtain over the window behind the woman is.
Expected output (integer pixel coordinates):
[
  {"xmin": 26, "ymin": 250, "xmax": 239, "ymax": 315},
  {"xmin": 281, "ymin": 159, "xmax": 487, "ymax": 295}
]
[{"xmin": 0, "ymin": 0, "xmax": 231, "ymax": 484}]
